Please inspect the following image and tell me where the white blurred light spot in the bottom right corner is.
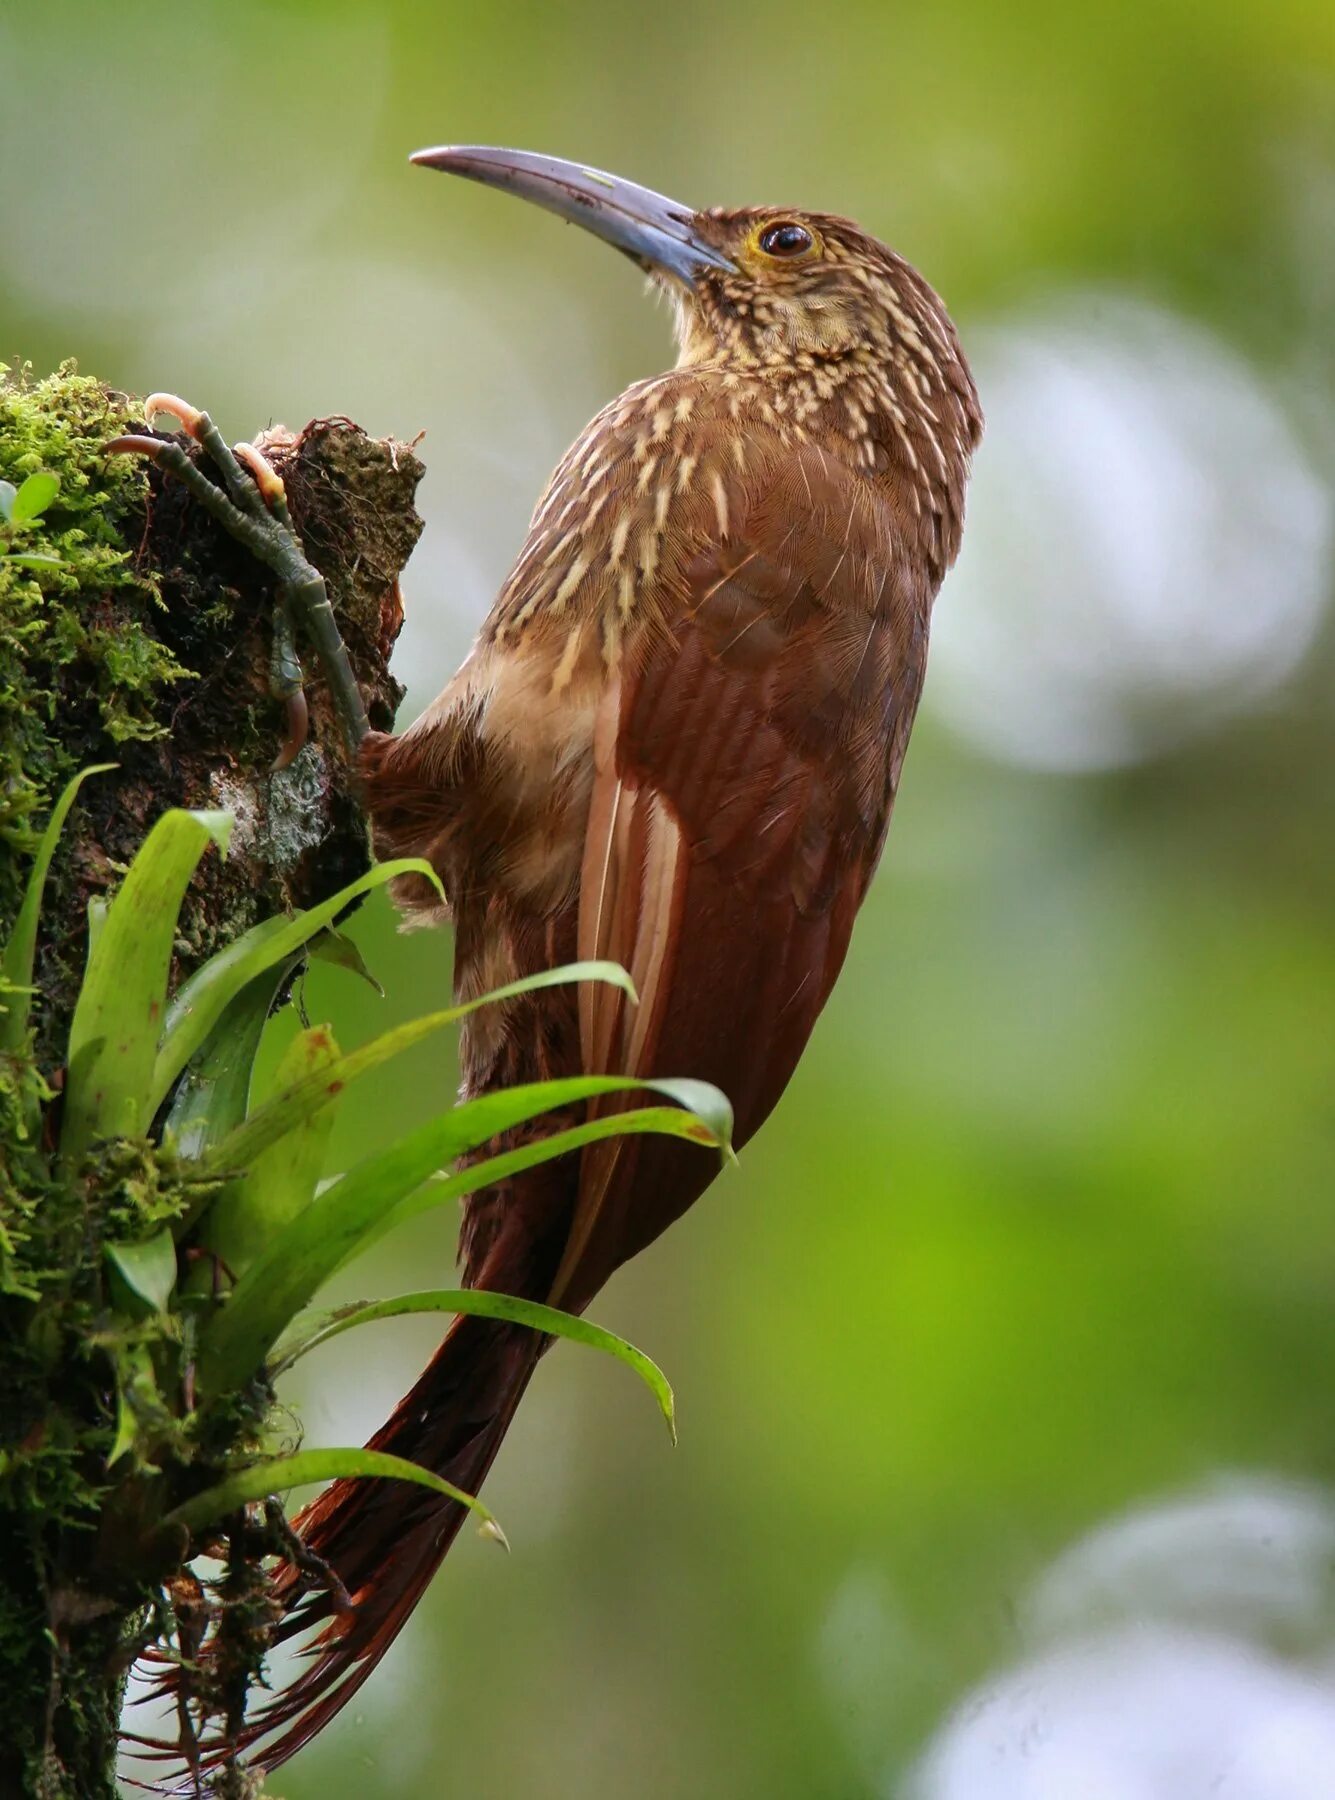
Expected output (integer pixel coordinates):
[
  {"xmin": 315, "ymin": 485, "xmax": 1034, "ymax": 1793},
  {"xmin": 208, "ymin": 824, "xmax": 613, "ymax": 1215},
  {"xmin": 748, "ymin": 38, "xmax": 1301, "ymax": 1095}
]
[{"xmin": 910, "ymin": 1476, "xmax": 1335, "ymax": 1800}]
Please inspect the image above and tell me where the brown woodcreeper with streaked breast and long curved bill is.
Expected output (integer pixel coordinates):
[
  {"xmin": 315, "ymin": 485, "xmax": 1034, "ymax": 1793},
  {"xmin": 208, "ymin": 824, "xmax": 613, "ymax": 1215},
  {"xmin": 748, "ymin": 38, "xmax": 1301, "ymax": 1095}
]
[{"xmin": 246, "ymin": 146, "xmax": 982, "ymax": 1768}]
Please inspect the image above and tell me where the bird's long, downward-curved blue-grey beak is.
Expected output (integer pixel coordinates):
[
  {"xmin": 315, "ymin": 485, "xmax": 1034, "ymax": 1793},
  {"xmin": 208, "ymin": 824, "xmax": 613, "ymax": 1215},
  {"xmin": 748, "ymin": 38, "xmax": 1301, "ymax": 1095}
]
[{"xmin": 408, "ymin": 144, "xmax": 736, "ymax": 286}]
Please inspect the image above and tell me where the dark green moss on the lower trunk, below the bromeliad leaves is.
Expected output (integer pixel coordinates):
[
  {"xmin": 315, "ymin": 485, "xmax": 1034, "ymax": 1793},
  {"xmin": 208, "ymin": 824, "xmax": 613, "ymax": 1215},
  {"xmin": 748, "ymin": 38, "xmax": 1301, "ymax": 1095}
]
[{"xmin": 0, "ymin": 1101, "xmax": 273, "ymax": 1800}]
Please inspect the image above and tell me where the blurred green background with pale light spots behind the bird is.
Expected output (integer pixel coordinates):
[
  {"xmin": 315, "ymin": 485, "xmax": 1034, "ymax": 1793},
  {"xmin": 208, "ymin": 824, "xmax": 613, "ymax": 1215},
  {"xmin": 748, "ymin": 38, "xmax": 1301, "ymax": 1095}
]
[{"xmin": 0, "ymin": 0, "xmax": 1335, "ymax": 1800}]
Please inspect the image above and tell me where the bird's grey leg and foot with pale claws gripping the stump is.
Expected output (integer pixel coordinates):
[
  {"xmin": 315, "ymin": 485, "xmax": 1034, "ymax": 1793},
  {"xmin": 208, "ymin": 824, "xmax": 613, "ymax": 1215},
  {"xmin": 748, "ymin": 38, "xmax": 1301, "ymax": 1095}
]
[{"xmin": 106, "ymin": 394, "xmax": 371, "ymax": 769}]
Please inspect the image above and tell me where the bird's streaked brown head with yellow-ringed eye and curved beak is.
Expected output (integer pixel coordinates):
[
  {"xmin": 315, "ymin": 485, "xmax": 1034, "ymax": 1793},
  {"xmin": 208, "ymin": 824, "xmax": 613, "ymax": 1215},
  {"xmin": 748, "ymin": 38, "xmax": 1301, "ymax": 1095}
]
[{"xmin": 412, "ymin": 146, "xmax": 982, "ymax": 493}]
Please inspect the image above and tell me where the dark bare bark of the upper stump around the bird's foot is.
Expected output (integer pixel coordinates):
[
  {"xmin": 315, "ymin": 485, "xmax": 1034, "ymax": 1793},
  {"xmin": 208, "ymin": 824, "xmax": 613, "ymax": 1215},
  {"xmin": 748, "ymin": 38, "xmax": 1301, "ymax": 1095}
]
[{"xmin": 20, "ymin": 403, "xmax": 423, "ymax": 1048}]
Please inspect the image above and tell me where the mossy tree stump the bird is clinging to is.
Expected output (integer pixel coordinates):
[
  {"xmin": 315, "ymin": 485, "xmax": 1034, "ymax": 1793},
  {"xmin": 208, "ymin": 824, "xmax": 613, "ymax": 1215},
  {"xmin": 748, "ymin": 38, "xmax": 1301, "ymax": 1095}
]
[{"xmin": 0, "ymin": 367, "xmax": 421, "ymax": 1800}]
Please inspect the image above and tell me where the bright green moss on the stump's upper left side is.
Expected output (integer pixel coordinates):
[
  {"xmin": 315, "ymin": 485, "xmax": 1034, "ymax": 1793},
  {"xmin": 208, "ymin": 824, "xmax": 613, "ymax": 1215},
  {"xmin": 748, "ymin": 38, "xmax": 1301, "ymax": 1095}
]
[{"xmin": 0, "ymin": 362, "xmax": 187, "ymax": 922}]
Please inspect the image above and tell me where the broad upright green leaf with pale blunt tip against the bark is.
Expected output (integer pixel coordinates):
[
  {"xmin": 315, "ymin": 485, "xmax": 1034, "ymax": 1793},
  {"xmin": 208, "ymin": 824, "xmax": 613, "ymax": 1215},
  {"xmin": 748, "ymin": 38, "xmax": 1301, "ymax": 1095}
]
[{"xmin": 61, "ymin": 810, "xmax": 232, "ymax": 1166}]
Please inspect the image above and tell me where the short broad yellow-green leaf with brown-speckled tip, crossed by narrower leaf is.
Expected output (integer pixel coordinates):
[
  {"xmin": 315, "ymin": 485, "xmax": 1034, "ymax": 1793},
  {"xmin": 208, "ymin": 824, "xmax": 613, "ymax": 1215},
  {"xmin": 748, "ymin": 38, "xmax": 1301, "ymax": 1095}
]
[{"xmin": 200, "ymin": 1024, "xmax": 338, "ymax": 1274}]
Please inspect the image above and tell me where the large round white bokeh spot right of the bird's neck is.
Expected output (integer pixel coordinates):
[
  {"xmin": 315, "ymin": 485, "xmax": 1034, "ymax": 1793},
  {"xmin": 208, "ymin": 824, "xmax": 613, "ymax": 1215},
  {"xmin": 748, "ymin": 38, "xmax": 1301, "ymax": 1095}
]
[{"xmin": 927, "ymin": 292, "xmax": 1331, "ymax": 770}]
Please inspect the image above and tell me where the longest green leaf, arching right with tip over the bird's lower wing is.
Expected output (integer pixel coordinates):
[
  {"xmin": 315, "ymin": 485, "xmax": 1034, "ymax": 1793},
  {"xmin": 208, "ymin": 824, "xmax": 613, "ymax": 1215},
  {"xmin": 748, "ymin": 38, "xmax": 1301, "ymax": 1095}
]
[{"xmin": 198, "ymin": 1076, "xmax": 727, "ymax": 1399}]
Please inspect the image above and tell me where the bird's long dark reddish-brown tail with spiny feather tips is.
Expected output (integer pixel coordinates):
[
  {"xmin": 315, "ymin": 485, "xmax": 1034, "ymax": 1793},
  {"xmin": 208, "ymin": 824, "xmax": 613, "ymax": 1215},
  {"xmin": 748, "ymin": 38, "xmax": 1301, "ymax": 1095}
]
[{"xmin": 243, "ymin": 1318, "xmax": 547, "ymax": 1769}]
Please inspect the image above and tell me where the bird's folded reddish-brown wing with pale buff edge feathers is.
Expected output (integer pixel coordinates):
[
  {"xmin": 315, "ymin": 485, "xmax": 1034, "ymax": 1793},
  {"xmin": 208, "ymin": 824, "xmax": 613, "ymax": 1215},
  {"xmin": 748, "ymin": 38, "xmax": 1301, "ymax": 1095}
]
[{"xmin": 554, "ymin": 439, "xmax": 927, "ymax": 1305}]
